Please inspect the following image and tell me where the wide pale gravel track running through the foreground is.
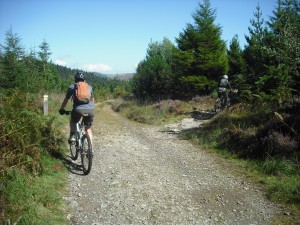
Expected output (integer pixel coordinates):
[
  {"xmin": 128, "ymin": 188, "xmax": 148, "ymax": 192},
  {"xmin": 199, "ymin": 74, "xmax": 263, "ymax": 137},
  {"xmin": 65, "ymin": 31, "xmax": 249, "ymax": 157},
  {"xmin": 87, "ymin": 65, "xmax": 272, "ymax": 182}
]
[{"xmin": 65, "ymin": 104, "xmax": 281, "ymax": 225}]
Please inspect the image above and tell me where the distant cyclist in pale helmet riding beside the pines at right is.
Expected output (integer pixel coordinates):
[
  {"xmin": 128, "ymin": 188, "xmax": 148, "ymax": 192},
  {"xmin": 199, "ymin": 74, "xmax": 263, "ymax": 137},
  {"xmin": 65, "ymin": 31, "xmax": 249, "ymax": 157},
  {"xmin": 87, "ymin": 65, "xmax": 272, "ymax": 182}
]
[{"xmin": 216, "ymin": 75, "xmax": 231, "ymax": 112}]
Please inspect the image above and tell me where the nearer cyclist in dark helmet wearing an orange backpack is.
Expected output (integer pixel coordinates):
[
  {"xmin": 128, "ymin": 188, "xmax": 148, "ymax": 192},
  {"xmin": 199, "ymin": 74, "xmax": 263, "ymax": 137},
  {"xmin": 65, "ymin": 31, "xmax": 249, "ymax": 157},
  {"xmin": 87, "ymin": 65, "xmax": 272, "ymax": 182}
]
[{"xmin": 59, "ymin": 72, "xmax": 94, "ymax": 142}]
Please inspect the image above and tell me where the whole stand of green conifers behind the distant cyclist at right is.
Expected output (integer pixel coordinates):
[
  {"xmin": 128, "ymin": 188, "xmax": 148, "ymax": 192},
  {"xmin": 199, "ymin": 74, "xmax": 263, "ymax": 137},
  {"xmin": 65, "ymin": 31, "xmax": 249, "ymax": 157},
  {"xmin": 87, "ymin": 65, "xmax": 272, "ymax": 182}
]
[{"xmin": 133, "ymin": 0, "xmax": 300, "ymax": 104}]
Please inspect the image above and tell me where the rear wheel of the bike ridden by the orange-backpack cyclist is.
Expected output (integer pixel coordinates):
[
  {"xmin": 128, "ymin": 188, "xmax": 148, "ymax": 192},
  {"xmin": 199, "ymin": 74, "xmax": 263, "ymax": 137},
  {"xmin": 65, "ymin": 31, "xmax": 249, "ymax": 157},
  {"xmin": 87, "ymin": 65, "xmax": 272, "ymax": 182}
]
[{"xmin": 81, "ymin": 134, "xmax": 93, "ymax": 174}]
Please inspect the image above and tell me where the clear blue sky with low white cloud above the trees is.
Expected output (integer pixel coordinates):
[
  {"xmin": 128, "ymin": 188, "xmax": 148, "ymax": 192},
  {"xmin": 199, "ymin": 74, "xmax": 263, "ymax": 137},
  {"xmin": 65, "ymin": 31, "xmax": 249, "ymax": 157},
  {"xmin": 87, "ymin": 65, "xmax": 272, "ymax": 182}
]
[{"xmin": 0, "ymin": 0, "xmax": 277, "ymax": 74}]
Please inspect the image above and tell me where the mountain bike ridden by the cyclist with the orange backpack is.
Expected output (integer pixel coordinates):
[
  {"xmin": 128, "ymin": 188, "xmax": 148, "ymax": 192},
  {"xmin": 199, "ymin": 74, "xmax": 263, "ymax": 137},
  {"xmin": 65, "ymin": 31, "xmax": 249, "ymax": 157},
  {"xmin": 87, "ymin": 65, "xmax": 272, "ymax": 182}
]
[{"xmin": 64, "ymin": 111, "xmax": 93, "ymax": 175}]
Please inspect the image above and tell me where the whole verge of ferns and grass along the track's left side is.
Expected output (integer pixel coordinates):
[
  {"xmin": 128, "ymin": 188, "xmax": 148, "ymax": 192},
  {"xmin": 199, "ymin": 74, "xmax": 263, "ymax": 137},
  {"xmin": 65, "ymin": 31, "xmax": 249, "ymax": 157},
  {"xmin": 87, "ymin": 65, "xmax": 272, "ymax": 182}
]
[{"xmin": 0, "ymin": 90, "xmax": 67, "ymax": 224}]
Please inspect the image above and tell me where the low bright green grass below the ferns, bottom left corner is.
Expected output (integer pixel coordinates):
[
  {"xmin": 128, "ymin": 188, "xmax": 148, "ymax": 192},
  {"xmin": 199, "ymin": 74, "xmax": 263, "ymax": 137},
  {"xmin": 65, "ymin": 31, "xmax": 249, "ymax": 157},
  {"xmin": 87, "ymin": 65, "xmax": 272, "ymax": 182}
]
[{"xmin": 4, "ymin": 156, "xmax": 67, "ymax": 224}]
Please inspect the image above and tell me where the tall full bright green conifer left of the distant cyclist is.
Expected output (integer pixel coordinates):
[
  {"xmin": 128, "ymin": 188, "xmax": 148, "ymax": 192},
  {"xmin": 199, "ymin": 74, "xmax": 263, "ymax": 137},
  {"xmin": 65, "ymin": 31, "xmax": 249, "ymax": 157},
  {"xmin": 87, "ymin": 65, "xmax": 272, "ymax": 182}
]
[{"xmin": 176, "ymin": 0, "xmax": 228, "ymax": 97}]
